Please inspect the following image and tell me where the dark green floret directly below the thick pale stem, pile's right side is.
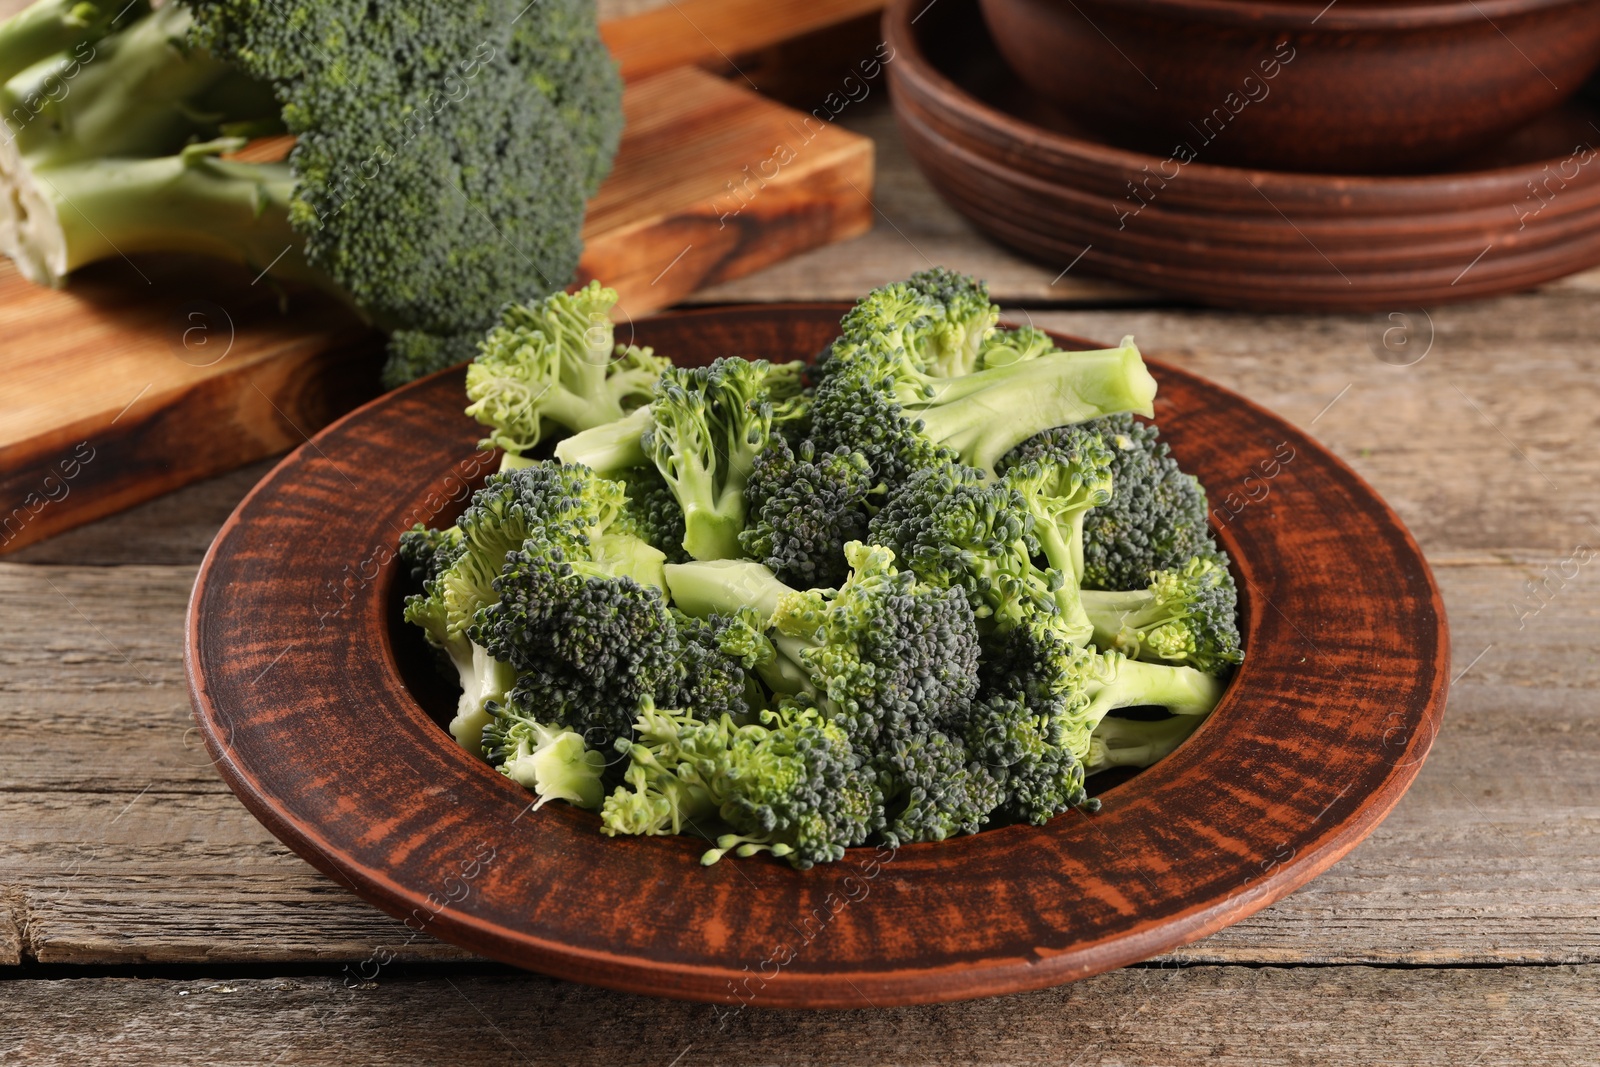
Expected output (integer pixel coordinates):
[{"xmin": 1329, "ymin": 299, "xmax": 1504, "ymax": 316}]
[{"xmin": 1002, "ymin": 414, "xmax": 1221, "ymax": 590}]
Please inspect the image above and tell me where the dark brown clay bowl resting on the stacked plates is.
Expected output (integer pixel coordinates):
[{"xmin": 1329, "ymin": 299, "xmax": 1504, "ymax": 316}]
[{"xmin": 982, "ymin": 0, "xmax": 1600, "ymax": 174}]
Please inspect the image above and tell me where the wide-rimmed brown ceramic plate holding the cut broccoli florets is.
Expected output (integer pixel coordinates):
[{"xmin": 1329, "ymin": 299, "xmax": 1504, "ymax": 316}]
[{"xmin": 187, "ymin": 304, "xmax": 1448, "ymax": 1009}]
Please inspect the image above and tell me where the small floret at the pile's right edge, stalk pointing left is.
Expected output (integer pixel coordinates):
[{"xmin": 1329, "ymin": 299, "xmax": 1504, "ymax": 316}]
[{"xmin": 1082, "ymin": 557, "xmax": 1245, "ymax": 675}]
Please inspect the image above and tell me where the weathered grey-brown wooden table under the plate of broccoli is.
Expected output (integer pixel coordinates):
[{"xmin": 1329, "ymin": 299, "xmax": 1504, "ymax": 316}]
[{"xmin": 0, "ymin": 101, "xmax": 1600, "ymax": 1067}]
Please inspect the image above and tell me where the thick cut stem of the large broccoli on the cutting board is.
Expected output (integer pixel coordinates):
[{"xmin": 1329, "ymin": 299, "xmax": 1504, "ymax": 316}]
[{"xmin": 0, "ymin": 141, "xmax": 315, "ymax": 290}]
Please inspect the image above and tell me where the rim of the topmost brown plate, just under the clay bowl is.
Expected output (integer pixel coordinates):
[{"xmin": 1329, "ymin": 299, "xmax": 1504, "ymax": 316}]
[{"xmin": 883, "ymin": 0, "xmax": 1600, "ymax": 195}]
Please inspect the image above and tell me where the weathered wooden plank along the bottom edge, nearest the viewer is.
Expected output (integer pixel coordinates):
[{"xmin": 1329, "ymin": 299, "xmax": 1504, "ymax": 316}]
[{"xmin": 0, "ymin": 966, "xmax": 1600, "ymax": 1067}]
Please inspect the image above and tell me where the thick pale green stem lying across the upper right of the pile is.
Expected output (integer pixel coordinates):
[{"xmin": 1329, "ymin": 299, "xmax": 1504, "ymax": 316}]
[{"xmin": 902, "ymin": 338, "xmax": 1155, "ymax": 474}]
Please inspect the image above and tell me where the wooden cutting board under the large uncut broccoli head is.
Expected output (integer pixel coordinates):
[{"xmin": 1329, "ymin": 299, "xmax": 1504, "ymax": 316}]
[{"xmin": 0, "ymin": 0, "xmax": 882, "ymax": 553}]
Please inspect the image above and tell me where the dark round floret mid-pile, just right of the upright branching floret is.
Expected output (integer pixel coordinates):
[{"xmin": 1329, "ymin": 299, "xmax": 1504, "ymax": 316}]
[{"xmin": 739, "ymin": 437, "xmax": 882, "ymax": 589}]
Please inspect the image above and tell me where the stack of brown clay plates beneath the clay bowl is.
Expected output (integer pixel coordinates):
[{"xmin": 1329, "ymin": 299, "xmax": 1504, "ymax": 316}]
[{"xmin": 885, "ymin": 0, "xmax": 1600, "ymax": 310}]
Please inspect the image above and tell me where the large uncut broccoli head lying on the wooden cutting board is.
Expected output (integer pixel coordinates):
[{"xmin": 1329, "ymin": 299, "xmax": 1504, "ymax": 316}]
[{"xmin": 0, "ymin": 0, "xmax": 622, "ymax": 382}]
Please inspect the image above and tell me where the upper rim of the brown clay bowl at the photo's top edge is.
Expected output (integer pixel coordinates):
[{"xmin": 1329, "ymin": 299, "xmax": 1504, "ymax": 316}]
[{"xmin": 1004, "ymin": 0, "xmax": 1594, "ymax": 34}]
